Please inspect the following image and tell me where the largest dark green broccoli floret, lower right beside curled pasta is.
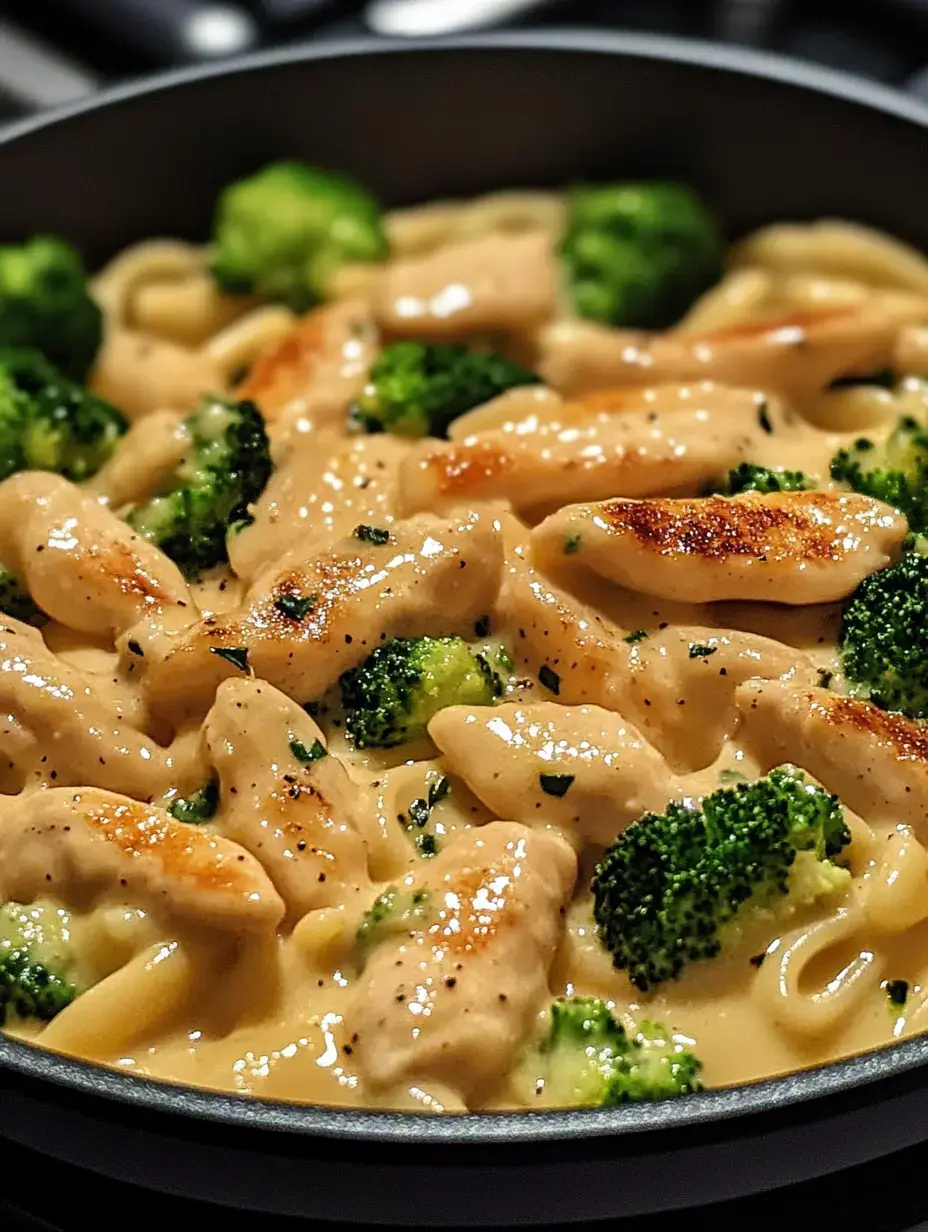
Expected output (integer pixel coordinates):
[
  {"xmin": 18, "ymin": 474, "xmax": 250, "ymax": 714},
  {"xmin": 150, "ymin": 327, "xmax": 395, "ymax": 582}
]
[{"xmin": 593, "ymin": 766, "xmax": 850, "ymax": 991}]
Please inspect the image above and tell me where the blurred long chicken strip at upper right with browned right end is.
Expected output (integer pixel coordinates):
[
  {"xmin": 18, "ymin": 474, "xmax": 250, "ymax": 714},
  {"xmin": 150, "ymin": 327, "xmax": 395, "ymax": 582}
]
[{"xmin": 537, "ymin": 296, "xmax": 923, "ymax": 403}]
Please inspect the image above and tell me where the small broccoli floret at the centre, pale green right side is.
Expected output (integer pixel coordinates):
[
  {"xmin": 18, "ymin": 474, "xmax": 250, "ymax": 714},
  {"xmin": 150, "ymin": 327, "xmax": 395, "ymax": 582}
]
[{"xmin": 339, "ymin": 637, "xmax": 503, "ymax": 749}]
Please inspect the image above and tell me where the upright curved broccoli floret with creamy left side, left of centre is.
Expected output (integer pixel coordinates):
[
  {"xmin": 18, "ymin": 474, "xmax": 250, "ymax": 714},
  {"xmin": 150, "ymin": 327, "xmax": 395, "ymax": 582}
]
[{"xmin": 126, "ymin": 397, "xmax": 272, "ymax": 579}]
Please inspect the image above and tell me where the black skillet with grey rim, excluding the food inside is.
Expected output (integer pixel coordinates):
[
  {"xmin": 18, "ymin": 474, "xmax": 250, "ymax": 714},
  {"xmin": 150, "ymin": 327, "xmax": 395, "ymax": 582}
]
[{"xmin": 0, "ymin": 31, "xmax": 928, "ymax": 1226}]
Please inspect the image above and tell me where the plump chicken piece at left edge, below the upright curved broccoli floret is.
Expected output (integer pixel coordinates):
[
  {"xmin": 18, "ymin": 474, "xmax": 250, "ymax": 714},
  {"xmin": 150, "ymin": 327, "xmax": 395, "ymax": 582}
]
[{"xmin": 0, "ymin": 471, "xmax": 195, "ymax": 636}]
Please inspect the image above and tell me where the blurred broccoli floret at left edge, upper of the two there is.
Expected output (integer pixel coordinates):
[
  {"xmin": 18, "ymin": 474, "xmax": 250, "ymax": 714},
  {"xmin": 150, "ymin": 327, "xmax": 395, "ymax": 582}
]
[{"xmin": 0, "ymin": 235, "xmax": 102, "ymax": 381}]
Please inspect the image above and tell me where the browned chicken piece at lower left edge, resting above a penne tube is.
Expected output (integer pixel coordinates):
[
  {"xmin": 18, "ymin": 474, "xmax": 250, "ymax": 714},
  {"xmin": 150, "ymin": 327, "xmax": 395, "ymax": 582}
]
[{"xmin": 0, "ymin": 787, "xmax": 283, "ymax": 931}]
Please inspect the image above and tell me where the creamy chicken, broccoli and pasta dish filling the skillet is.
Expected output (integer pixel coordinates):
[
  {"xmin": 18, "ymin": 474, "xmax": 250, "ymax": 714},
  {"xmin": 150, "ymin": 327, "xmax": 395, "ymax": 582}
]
[{"xmin": 0, "ymin": 161, "xmax": 928, "ymax": 1112}]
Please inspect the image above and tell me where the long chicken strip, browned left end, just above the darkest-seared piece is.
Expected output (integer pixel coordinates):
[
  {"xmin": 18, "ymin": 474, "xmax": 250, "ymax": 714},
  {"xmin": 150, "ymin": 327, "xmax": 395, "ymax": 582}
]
[{"xmin": 399, "ymin": 387, "xmax": 763, "ymax": 514}]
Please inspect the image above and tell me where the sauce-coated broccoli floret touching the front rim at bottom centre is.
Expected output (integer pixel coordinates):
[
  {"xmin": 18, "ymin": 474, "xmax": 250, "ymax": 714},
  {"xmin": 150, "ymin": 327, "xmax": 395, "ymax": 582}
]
[{"xmin": 540, "ymin": 997, "xmax": 702, "ymax": 1108}]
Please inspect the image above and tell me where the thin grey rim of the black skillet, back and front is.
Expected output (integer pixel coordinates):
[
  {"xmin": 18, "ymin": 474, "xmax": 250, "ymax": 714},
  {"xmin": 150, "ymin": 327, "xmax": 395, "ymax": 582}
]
[{"xmin": 0, "ymin": 28, "xmax": 928, "ymax": 1147}]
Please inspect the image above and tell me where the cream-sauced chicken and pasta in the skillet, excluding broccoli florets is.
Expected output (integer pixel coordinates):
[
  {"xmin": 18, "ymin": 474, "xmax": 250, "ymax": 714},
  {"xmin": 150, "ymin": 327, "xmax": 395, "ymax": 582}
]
[{"xmin": 0, "ymin": 176, "xmax": 928, "ymax": 1128}]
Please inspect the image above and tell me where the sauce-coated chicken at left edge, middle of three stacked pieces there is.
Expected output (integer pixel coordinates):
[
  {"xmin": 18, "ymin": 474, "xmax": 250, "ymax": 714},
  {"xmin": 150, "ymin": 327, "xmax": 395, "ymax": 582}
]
[{"xmin": 0, "ymin": 618, "xmax": 198, "ymax": 798}]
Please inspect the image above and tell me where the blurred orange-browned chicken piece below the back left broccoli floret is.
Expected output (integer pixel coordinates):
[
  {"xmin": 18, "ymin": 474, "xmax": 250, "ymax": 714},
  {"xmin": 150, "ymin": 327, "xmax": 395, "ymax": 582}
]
[{"xmin": 235, "ymin": 299, "xmax": 378, "ymax": 424}]
